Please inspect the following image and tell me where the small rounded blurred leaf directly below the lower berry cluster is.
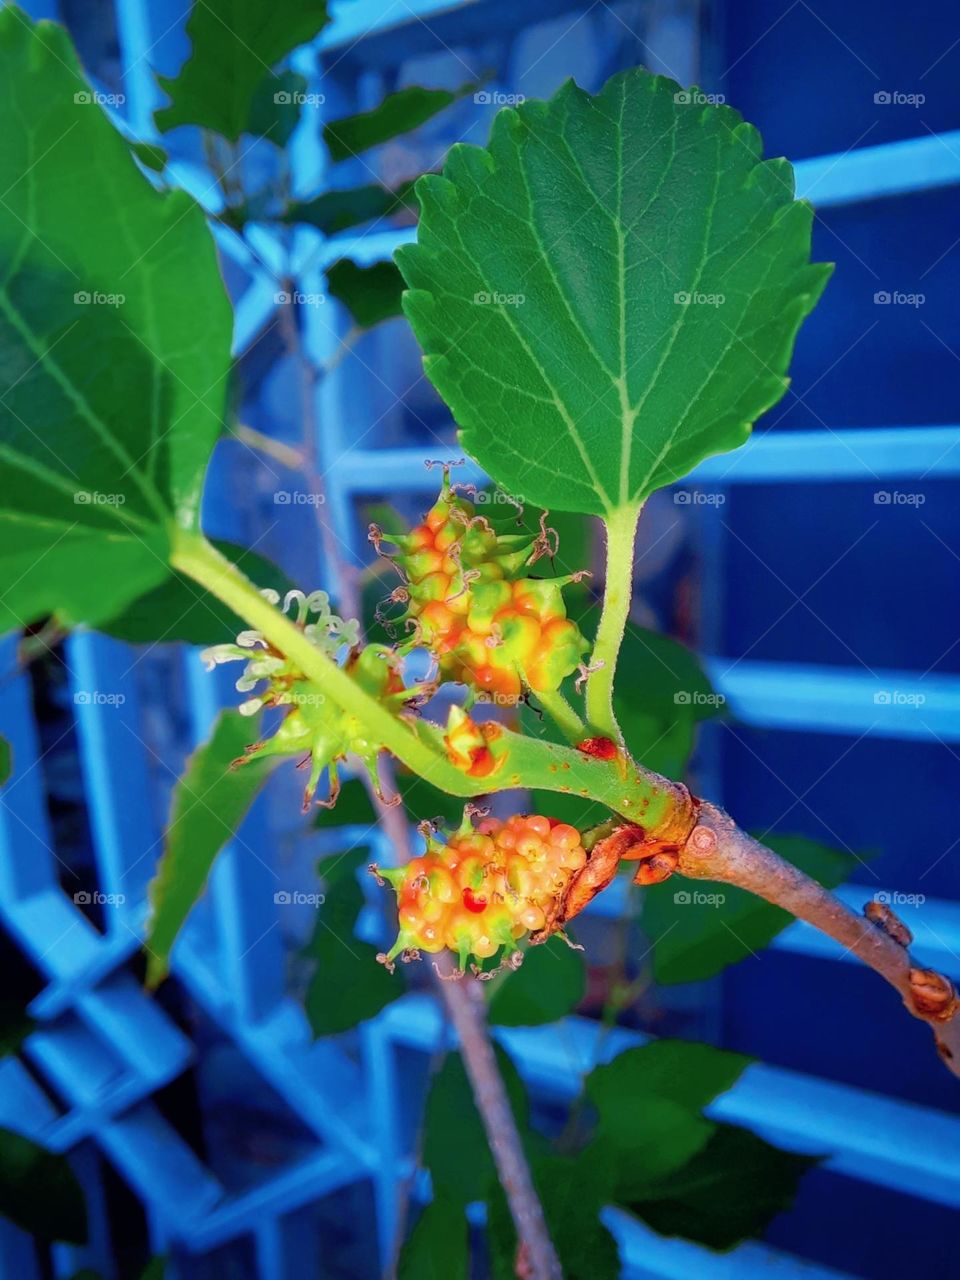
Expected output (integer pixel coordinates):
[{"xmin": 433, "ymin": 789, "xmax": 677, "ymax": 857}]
[{"xmin": 488, "ymin": 937, "xmax": 586, "ymax": 1027}]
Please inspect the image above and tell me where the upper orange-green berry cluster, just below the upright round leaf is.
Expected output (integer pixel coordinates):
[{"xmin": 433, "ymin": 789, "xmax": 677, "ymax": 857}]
[{"xmin": 371, "ymin": 475, "xmax": 588, "ymax": 705}]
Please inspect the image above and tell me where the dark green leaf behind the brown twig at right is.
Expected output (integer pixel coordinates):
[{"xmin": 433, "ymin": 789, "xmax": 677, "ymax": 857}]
[{"xmin": 643, "ymin": 836, "xmax": 854, "ymax": 984}]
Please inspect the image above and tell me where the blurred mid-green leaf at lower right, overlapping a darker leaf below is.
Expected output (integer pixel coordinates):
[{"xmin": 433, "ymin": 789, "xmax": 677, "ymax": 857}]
[{"xmin": 585, "ymin": 1039, "xmax": 750, "ymax": 1199}]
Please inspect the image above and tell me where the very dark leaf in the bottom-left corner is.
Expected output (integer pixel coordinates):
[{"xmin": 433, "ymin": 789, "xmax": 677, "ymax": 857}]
[{"xmin": 0, "ymin": 1129, "xmax": 87, "ymax": 1244}]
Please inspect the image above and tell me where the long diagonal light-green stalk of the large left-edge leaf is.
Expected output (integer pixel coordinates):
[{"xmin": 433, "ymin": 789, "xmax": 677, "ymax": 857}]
[{"xmin": 172, "ymin": 531, "xmax": 475, "ymax": 795}]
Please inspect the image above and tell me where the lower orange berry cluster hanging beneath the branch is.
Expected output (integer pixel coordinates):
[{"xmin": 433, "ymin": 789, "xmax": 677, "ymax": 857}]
[{"xmin": 370, "ymin": 810, "xmax": 586, "ymax": 970}]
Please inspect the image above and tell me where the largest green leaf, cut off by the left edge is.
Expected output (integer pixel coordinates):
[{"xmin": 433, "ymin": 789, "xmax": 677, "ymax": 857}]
[{"xmin": 0, "ymin": 8, "xmax": 232, "ymax": 631}]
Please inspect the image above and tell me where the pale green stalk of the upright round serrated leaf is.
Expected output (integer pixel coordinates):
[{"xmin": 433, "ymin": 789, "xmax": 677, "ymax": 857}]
[{"xmin": 586, "ymin": 507, "xmax": 640, "ymax": 742}]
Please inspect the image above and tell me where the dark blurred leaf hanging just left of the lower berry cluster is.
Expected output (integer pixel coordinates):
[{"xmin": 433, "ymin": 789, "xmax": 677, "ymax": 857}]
[{"xmin": 303, "ymin": 846, "xmax": 406, "ymax": 1036}]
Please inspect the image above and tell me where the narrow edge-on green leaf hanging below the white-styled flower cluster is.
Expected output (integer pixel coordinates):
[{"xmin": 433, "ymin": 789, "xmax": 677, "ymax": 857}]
[{"xmin": 145, "ymin": 710, "xmax": 276, "ymax": 987}]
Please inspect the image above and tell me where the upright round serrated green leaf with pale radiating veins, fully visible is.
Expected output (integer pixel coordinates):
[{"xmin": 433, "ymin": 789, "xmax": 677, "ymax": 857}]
[{"xmin": 397, "ymin": 69, "xmax": 829, "ymax": 515}]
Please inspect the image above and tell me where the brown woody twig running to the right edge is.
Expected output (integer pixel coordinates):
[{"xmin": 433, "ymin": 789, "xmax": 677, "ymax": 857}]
[{"xmin": 677, "ymin": 804, "xmax": 960, "ymax": 1075}]
